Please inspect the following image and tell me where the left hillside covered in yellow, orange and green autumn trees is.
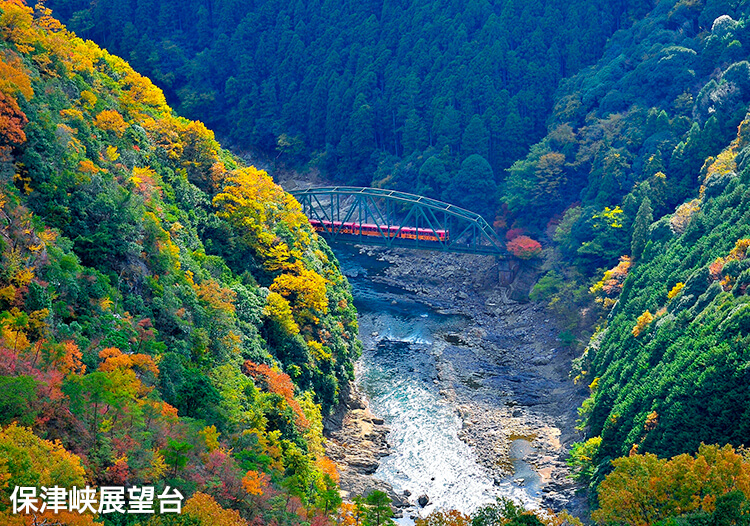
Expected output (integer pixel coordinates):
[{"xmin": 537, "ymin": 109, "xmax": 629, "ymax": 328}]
[{"xmin": 0, "ymin": 0, "xmax": 359, "ymax": 525}]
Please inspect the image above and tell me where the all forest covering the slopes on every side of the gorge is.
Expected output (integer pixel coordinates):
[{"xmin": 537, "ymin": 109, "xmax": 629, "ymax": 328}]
[{"xmin": 0, "ymin": 0, "xmax": 750, "ymax": 526}]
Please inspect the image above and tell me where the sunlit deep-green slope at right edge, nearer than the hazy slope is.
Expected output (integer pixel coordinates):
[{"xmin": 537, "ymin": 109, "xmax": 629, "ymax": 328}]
[{"xmin": 583, "ymin": 110, "xmax": 750, "ymax": 486}]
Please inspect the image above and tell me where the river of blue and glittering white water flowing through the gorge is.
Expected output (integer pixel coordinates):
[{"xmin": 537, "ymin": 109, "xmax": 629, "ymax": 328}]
[{"xmin": 336, "ymin": 247, "xmax": 541, "ymax": 524}]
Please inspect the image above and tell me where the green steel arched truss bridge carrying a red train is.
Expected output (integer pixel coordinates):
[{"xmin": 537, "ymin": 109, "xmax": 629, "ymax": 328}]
[{"xmin": 290, "ymin": 186, "xmax": 507, "ymax": 257}]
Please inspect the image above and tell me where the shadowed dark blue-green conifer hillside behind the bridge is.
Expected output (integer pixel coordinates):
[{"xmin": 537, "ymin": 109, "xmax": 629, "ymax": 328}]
[{"xmin": 48, "ymin": 0, "xmax": 651, "ymax": 219}]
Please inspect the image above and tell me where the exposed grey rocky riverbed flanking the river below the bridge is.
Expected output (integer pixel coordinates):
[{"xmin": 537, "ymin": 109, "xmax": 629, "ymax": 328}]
[{"xmin": 327, "ymin": 248, "xmax": 587, "ymax": 515}]
